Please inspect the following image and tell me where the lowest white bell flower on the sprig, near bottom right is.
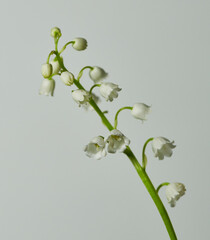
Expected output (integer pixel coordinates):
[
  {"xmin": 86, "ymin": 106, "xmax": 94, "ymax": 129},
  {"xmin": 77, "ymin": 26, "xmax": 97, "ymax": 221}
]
[{"xmin": 165, "ymin": 183, "xmax": 186, "ymax": 207}]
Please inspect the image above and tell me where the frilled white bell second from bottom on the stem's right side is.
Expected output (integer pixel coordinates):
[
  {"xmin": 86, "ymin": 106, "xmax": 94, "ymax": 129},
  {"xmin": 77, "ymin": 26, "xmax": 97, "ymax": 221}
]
[{"xmin": 152, "ymin": 137, "xmax": 176, "ymax": 160}]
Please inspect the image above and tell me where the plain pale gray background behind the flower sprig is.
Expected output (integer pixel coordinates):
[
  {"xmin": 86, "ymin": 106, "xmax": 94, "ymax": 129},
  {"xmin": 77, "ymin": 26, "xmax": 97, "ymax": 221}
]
[{"xmin": 0, "ymin": 0, "xmax": 210, "ymax": 240}]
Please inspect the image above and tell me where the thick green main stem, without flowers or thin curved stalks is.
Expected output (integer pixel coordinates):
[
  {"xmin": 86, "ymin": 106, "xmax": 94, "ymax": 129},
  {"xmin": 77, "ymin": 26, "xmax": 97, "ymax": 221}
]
[{"xmin": 51, "ymin": 51, "xmax": 177, "ymax": 240}]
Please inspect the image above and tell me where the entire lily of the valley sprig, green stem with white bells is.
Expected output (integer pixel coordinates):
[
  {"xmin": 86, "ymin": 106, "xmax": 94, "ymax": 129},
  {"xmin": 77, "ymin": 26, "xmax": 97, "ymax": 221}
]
[{"xmin": 39, "ymin": 27, "xmax": 186, "ymax": 240}]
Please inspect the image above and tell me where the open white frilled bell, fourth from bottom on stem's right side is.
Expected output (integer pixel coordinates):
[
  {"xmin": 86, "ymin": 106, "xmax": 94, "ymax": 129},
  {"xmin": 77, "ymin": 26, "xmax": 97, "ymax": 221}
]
[{"xmin": 99, "ymin": 82, "xmax": 121, "ymax": 102}]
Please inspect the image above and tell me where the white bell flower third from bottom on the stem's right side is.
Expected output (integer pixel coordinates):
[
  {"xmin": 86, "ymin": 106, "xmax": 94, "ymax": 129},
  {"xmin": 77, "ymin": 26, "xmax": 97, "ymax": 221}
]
[{"xmin": 131, "ymin": 103, "xmax": 151, "ymax": 122}]
